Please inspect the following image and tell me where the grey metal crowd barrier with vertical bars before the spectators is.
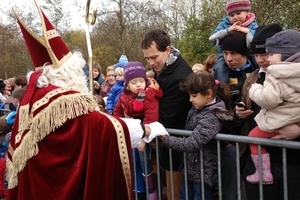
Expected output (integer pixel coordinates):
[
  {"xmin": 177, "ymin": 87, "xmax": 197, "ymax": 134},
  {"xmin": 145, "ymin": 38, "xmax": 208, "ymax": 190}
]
[{"xmin": 133, "ymin": 129, "xmax": 300, "ymax": 200}]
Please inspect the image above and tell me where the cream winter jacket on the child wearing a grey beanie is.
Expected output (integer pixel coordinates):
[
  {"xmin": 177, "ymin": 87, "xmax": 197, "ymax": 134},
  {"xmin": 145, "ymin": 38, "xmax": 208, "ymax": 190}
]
[{"xmin": 249, "ymin": 62, "xmax": 300, "ymax": 132}]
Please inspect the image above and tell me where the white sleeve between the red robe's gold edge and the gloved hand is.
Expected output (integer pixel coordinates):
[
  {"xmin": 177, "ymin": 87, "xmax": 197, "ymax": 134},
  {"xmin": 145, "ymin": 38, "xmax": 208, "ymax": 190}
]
[{"xmin": 121, "ymin": 118, "xmax": 144, "ymax": 148}]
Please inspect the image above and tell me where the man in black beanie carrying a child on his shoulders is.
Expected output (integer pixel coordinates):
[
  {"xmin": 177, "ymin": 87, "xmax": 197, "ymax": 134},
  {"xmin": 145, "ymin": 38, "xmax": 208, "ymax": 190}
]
[{"xmin": 221, "ymin": 31, "xmax": 258, "ymax": 200}]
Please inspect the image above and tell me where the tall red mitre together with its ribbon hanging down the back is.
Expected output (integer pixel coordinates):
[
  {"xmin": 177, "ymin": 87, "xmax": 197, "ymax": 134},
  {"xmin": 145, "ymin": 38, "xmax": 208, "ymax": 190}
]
[{"xmin": 13, "ymin": 0, "xmax": 72, "ymax": 136}]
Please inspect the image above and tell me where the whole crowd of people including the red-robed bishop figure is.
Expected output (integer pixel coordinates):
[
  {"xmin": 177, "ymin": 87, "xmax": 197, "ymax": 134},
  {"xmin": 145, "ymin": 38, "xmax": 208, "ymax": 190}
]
[{"xmin": 0, "ymin": 0, "xmax": 300, "ymax": 200}]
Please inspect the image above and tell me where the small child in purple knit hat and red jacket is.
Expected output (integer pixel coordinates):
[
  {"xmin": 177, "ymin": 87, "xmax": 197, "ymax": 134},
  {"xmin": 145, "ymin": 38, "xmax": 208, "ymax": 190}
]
[{"xmin": 114, "ymin": 62, "xmax": 163, "ymax": 199}]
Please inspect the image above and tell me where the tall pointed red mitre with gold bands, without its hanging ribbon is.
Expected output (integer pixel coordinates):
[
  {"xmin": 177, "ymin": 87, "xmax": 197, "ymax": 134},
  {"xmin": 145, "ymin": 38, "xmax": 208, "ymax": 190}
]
[{"xmin": 13, "ymin": 0, "xmax": 72, "ymax": 70}]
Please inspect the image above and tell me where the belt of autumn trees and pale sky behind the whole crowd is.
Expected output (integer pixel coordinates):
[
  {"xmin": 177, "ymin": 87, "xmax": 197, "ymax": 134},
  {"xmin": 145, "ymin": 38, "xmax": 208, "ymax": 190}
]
[{"xmin": 0, "ymin": 0, "xmax": 300, "ymax": 78}]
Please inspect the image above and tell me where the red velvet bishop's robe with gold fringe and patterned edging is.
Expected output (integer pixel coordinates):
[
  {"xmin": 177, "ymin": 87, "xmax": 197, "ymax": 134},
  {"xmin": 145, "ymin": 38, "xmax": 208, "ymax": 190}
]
[{"xmin": 7, "ymin": 85, "xmax": 133, "ymax": 200}]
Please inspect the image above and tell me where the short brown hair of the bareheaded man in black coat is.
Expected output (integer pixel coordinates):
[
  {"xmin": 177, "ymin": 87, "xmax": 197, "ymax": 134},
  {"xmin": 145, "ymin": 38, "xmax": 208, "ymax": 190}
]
[{"xmin": 141, "ymin": 29, "xmax": 171, "ymax": 51}]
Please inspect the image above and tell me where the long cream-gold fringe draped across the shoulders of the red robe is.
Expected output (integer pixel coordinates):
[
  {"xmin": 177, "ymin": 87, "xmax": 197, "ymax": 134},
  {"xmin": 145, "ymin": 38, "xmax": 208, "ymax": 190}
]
[{"xmin": 7, "ymin": 90, "xmax": 97, "ymax": 189}]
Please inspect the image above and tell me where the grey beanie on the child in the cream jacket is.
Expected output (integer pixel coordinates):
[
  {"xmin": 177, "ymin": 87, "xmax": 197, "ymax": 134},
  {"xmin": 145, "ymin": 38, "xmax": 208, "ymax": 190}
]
[{"xmin": 266, "ymin": 29, "xmax": 300, "ymax": 61}]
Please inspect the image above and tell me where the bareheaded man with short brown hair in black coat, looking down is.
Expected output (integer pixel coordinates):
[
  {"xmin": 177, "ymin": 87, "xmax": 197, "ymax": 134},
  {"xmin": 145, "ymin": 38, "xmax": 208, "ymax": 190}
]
[{"xmin": 141, "ymin": 29, "xmax": 192, "ymax": 200}]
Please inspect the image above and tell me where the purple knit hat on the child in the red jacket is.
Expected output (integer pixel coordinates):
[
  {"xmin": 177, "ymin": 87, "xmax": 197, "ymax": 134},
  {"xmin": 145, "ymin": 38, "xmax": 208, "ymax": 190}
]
[{"xmin": 124, "ymin": 61, "xmax": 150, "ymax": 86}]
